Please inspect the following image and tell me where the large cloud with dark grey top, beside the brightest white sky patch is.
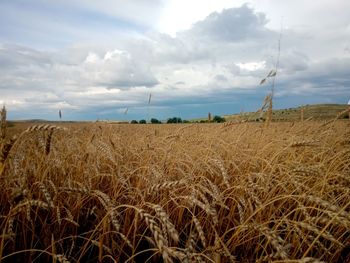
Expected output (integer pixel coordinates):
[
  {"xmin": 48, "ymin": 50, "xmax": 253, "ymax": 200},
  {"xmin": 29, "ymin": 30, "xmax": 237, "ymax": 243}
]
[{"xmin": 116, "ymin": 5, "xmax": 278, "ymax": 67}]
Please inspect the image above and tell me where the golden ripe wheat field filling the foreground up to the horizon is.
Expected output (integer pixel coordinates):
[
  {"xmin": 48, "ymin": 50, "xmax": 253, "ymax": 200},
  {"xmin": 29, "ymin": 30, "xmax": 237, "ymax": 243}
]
[{"xmin": 0, "ymin": 118, "xmax": 350, "ymax": 263}]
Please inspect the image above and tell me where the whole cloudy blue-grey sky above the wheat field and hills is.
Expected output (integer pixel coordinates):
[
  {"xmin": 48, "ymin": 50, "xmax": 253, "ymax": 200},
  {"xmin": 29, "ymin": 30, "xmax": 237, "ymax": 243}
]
[{"xmin": 0, "ymin": 0, "xmax": 350, "ymax": 120}]
